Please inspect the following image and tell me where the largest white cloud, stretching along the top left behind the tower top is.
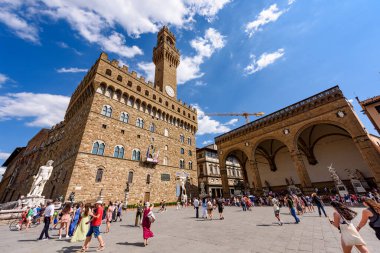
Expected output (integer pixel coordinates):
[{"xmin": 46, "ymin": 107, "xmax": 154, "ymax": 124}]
[{"xmin": 0, "ymin": 0, "xmax": 230, "ymax": 58}]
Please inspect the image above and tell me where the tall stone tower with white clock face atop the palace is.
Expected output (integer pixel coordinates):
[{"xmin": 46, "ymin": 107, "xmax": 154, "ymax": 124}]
[{"xmin": 153, "ymin": 26, "xmax": 179, "ymax": 98}]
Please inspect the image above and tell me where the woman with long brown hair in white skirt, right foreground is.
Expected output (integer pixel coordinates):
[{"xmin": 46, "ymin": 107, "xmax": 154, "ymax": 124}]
[{"xmin": 330, "ymin": 201, "xmax": 369, "ymax": 253}]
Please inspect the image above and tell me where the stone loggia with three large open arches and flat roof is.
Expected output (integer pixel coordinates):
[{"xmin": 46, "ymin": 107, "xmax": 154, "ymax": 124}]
[{"xmin": 215, "ymin": 86, "xmax": 380, "ymax": 196}]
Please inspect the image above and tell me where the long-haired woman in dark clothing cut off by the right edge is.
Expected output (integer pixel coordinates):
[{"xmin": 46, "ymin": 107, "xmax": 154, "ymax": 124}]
[{"xmin": 356, "ymin": 198, "xmax": 380, "ymax": 240}]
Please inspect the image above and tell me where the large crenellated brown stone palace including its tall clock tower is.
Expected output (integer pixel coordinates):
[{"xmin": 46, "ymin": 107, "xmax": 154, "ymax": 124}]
[{"xmin": 0, "ymin": 27, "xmax": 198, "ymax": 203}]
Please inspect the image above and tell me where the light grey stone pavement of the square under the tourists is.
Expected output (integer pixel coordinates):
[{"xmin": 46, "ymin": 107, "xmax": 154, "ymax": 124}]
[{"xmin": 0, "ymin": 207, "xmax": 380, "ymax": 253}]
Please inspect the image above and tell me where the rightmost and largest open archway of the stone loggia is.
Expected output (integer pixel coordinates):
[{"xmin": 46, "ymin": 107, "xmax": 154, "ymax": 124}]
[{"xmin": 295, "ymin": 121, "xmax": 376, "ymax": 189}]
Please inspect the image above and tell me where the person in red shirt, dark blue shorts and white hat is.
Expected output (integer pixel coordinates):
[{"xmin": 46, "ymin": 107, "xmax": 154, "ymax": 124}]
[{"xmin": 79, "ymin": 200, "xmax": 105, "ymax": 252}]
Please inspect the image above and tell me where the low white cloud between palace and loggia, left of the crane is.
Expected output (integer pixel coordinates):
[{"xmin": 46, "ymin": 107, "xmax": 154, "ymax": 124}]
[{"xmin": 193, "ymin": 105, "xmax": 231, "ymax": 135}]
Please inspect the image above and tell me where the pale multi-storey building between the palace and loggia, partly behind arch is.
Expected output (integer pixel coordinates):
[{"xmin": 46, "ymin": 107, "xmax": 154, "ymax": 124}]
[{"xmin": 197, "ymin": 144, "xmax": 244, "ymax": 197}]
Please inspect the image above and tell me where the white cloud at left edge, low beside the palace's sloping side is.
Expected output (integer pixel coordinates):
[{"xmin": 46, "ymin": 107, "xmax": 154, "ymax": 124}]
[{"xmin": 0, "ymin": 92, "xmax": 70, "ymax": 127}]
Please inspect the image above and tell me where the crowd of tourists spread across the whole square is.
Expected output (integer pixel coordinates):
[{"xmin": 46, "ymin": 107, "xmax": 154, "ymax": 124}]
[{"xmin": 12, "ymin": 191, "xmax": 380, "ymax": 253}]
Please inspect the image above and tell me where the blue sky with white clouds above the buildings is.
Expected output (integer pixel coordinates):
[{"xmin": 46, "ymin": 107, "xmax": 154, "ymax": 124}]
[{"xmin": 0, "ymin": 0, "xmax": 380, "ymax": 167}]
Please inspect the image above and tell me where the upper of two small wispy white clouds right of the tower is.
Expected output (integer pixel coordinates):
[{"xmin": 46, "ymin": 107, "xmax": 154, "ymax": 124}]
[{"xmin": 245, "ymin": 4, "xmax": 286, "ymax": 37}]
